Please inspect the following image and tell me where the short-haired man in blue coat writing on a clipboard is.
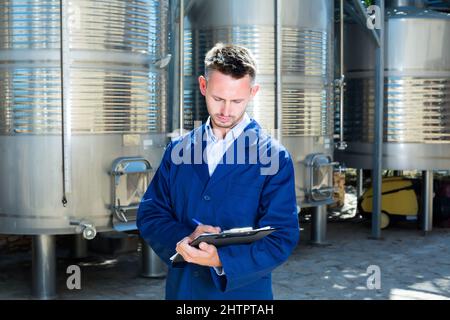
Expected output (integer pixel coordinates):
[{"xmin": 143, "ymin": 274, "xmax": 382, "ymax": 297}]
[{"xmin": 137, "ymin": 44, "xmax": 299, "ymax": 299}]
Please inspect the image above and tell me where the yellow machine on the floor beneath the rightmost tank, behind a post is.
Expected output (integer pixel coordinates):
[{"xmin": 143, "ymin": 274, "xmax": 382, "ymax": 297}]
[{"xmin": 361, "ymin": 177, "xmax": 419, "ymax": 218}]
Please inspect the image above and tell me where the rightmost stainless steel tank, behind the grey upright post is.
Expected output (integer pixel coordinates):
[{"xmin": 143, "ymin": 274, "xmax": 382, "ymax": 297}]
[{"xmin": 336, "ymin": 1, "xmax": 450, "ymax": 170}]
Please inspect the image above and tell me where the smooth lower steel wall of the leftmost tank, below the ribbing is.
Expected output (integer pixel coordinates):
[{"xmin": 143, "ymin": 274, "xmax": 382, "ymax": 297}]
[{"xmin": 0, "ymin": 134, "xmax": 167, "ymax": 234}]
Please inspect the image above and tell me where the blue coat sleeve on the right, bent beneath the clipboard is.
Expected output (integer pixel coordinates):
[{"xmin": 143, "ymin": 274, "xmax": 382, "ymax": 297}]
[{"xmin": 211, "ymin": 151, "xmax": 300, "ymax": 292}]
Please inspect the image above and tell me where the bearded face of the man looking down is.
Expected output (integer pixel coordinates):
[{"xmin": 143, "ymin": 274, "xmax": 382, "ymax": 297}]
[{"xmin": 198, "ymin": 70, "xmax": 259, "ymax": 129}]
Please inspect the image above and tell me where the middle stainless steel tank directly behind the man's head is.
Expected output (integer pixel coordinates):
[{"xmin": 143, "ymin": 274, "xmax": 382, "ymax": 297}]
[{"xmin": 183, "ymin": 0, "xmax": 334, "ymax": 206}]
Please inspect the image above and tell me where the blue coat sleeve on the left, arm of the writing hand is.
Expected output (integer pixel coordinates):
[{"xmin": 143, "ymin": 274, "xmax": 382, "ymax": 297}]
[{"xmin": 136, "ymin": 143, "xmax": 194, "ymax": 265}]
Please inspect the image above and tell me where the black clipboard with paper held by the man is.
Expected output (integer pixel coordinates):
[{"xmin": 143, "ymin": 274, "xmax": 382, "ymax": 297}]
[{"xmin": 170, "ymin": 227, "xmax": 276, "ymax": 264}]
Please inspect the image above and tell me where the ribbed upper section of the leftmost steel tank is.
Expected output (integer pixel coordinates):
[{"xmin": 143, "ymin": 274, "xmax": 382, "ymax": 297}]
[{"xmin": 0, "ymin": 0, "xmax": 168, "ymax": 135}]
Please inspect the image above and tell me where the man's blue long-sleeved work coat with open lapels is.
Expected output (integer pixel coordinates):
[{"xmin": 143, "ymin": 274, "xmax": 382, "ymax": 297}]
[{"xmin": 137, "ymin": 120, "xmax": 299, "ymax": 300}]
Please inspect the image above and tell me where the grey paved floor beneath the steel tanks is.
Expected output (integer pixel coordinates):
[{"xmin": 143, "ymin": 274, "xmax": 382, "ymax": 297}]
[{"xmin": 0, "ymin": 221, "xmax": 450, "ymax": 300}]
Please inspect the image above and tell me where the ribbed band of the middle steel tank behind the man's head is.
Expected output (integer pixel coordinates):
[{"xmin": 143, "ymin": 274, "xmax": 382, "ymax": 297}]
[{"xmin": 184, "ymin": 21, "xmax": 332, "ymax": 136}]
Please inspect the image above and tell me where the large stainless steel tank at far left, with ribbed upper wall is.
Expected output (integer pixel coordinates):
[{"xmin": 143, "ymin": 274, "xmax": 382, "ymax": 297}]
[{"xmin": 0, "ymin": 0, "xmax": 168, "ymax": 238}]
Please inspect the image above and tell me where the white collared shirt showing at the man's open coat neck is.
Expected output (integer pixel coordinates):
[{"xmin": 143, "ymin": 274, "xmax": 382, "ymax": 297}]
[{"xmin": 205, "ymin": 113, "xmax": 251, "ymax": 177}]
